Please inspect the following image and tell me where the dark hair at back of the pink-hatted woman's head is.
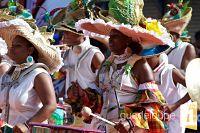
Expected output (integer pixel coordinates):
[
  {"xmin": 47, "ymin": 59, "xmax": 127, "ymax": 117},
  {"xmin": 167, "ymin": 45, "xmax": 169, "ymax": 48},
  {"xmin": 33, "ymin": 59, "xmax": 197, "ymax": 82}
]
[{"xmin": 128, "ymin": 41, "xmax": 143, "ymax": 54}]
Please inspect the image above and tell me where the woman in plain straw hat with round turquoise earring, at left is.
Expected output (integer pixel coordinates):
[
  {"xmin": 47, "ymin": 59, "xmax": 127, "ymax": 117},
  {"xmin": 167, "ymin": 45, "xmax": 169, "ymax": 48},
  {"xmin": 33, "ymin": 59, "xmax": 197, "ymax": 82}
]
[{"xmin": 0, "ymin": 16, "xmax": 62, "ymax": 133}]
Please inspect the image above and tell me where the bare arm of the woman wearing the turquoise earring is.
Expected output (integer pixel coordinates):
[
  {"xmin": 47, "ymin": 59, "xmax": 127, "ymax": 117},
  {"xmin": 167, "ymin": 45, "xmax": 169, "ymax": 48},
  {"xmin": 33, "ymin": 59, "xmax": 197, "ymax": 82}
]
[{"xmin": 28, "ymin": 73, "xmax": 56, "ymax": 123}]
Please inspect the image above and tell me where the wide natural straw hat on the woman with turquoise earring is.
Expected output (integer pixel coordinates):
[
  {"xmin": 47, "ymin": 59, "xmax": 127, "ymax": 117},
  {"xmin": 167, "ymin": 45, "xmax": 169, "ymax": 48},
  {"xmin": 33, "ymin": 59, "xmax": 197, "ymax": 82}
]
[{"xmin": 0, "ymin": 22, "xmax": 63, "ymax": 73}]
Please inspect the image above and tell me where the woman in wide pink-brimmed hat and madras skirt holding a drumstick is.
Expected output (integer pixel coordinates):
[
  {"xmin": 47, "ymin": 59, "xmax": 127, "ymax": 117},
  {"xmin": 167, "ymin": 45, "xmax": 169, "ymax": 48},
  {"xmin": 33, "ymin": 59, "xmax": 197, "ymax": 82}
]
[{"xmin": 76, "ymin": 1, "xmax": 174, "ymax": 133}]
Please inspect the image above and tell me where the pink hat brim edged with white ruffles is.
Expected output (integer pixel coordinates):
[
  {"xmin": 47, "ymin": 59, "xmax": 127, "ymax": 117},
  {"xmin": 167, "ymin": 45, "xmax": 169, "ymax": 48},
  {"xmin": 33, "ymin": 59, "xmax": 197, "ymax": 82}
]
[{"xmin": 76, "ymin": 19, "xmax": 174, "ymax": 49}]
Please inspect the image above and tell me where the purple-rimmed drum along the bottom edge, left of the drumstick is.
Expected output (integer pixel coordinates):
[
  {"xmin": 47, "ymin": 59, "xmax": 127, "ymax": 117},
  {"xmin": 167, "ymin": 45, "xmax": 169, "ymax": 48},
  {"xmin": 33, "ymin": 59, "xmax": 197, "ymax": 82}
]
[{"xmin": 30, "ymin": 123, "xmax": 104, "ymax": 133}]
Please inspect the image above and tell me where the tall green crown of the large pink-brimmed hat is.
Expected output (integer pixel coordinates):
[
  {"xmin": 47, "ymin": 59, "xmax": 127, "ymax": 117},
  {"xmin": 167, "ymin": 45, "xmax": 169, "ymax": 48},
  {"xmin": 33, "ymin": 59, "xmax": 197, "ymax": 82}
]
[{"xmin": 109, "ymin": 0, "xmax": 144, "ymax": 25}]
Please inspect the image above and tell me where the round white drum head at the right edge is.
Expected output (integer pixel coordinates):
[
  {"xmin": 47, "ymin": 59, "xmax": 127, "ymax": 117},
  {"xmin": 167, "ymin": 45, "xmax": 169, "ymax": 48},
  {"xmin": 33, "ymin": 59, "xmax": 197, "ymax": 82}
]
[{"xmin": 185, "ymin": 58, "xmax": 200, "ymax": 110}]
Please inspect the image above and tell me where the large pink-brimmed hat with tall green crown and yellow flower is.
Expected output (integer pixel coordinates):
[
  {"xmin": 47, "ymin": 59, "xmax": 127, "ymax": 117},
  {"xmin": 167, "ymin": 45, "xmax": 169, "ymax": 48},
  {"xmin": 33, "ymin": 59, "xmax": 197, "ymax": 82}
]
[{"xmin": 76, "ymin": 0, "xmax": 174, "ymax": 56}]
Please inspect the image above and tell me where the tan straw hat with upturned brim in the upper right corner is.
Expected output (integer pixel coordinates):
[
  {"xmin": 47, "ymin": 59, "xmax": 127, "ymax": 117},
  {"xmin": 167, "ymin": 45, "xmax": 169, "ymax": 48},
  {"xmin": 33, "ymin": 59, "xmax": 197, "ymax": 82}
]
[{"xmin": 162, "ymin": 7, "xmax": 192, "ymax": 35}]
